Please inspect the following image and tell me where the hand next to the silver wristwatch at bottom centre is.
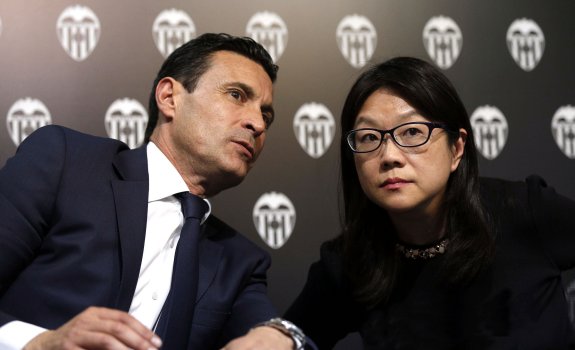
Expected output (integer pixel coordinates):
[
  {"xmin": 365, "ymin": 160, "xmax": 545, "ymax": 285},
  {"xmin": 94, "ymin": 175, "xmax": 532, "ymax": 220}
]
[{"xmin": 222, "ymin": 326, "xmax": 294, "ymax": 350}]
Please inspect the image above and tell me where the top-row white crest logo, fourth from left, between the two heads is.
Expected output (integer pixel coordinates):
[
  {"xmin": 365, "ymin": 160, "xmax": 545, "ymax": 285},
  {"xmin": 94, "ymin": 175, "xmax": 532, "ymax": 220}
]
[{"xmin": 335, "ymin": 15, "xmax": 377, "ymax": 68}]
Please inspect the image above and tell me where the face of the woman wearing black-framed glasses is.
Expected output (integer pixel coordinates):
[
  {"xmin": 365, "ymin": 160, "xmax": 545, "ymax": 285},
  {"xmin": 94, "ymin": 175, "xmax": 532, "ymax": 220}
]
[{"xmin": 354, "ymin": 89, "xmax": 467, "ymax": 215}]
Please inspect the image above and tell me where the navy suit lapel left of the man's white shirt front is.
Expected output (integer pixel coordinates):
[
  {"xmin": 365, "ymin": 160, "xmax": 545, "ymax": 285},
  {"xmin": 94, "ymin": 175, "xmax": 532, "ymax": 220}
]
[{"xmin": 112, "ymin": 146, "xmax": 149, "ymax": 311}]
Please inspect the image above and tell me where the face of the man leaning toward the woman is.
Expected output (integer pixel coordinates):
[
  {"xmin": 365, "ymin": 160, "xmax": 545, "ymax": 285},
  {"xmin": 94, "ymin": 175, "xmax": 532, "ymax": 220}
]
[{"xmin": 165, "ymin": 51, "xmax": 274, "ymax": 195}]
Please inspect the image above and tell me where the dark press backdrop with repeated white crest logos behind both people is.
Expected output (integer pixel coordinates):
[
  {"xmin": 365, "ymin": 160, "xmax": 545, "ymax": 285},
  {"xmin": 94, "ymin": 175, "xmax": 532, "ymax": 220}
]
[{"xmin": 0, "ymin": 0, "xmax": 575, "ymax": 348}]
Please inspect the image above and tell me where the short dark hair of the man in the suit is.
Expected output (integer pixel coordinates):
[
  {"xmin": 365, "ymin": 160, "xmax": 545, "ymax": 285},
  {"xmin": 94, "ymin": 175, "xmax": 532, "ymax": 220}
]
[{"xmin": 144, "ymin": 33, "xmax": 278, "ymax": 142}]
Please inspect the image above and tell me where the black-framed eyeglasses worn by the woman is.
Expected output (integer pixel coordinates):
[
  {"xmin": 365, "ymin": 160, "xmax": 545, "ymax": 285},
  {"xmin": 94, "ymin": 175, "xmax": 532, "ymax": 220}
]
[{"xmin": 346, "ymin": 122, "xmax": 451, "ymax": 153}]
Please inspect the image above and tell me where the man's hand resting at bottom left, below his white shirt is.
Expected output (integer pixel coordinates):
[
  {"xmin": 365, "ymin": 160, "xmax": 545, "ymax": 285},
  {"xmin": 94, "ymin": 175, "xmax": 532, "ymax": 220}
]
[{"xmin": 24, "ymin": 307, "xmax": 162, "ymax": 350}]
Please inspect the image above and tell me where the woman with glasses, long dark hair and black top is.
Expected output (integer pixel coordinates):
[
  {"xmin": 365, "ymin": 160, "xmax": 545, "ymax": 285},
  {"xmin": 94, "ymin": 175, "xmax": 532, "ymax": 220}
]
[{"xmin": 286, "ymin": 57, "xmax": 575, "ymax": 349}]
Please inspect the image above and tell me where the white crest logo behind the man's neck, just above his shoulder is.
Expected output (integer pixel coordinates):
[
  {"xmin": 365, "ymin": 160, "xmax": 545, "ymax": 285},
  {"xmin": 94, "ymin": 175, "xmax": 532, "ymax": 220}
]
[{"xmin": 105, "ymin": 98, "xmax": 148, "ymax": 148}]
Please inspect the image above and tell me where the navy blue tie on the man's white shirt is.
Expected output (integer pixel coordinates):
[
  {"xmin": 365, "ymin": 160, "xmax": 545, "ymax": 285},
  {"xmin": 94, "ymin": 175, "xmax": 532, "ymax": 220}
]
[{"xmin": 156, "ymin": 192, "xmax": 208, "ymax": 350}]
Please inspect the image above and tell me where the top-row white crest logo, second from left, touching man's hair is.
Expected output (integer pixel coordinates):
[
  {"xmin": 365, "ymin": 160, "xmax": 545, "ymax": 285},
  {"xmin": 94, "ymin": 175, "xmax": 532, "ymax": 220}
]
[{"xmin": 152, "ymin": 9, "xmax": 196, "ymax": 57}]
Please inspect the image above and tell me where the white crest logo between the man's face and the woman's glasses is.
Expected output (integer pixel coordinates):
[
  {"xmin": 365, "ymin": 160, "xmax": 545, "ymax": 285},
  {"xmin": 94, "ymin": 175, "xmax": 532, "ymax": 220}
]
[{"xmin": 293, "ymin": 102, "xmax": 335, "ymax": 158}]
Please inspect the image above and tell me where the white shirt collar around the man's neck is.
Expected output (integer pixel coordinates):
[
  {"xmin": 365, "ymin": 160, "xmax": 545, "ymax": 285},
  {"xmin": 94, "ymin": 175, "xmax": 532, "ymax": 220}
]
[{"xmin": 146, "ymin": 142, "xmax": 212, "ymax": 223}]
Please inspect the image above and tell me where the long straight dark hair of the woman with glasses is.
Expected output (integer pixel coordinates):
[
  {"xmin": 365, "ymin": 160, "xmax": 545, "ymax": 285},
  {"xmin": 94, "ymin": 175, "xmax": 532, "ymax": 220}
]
[{"xmin": 339, "ymin": 57, "xmax": 494, "ymax": 307}]
